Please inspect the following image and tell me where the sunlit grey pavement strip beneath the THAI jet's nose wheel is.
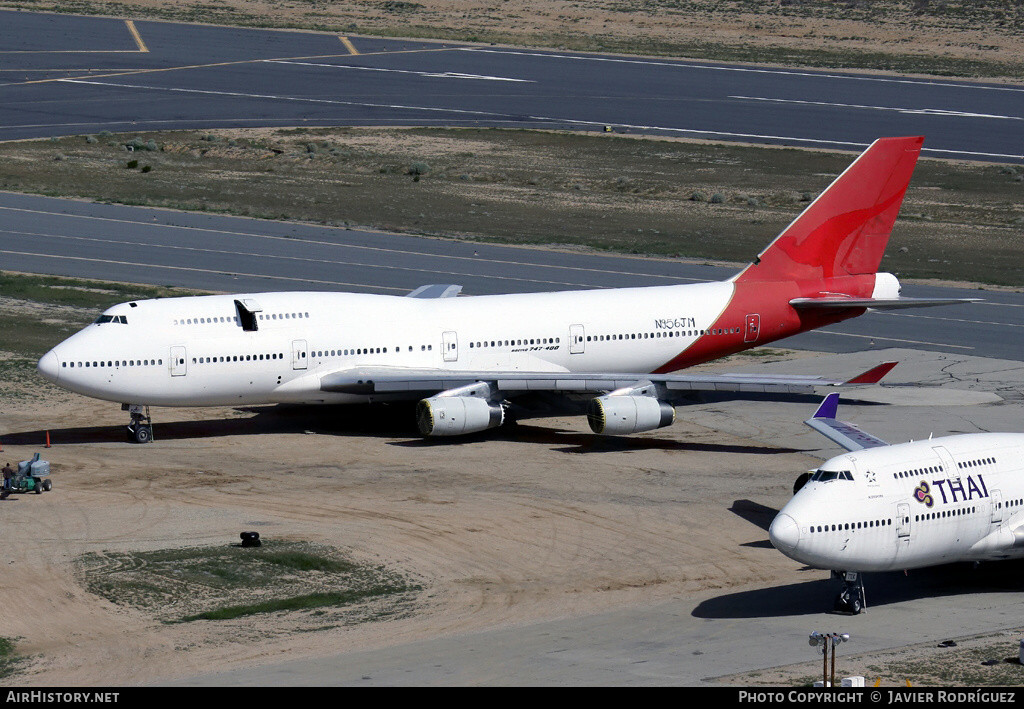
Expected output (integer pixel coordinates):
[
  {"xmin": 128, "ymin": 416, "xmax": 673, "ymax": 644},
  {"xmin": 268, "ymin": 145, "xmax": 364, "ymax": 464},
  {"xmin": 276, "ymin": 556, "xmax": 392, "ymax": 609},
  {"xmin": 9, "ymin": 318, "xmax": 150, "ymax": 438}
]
[{"xmin": 177, "ymin": 566, "xmax": 1024, "ymax": 684}]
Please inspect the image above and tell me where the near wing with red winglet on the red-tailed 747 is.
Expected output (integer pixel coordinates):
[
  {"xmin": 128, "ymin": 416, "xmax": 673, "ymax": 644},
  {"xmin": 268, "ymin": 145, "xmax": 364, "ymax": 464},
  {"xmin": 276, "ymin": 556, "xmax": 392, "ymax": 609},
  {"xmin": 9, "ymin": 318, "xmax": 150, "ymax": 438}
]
[{"xmin": 321, "ymin": 362, "xmax": 896, "ymax": 399}]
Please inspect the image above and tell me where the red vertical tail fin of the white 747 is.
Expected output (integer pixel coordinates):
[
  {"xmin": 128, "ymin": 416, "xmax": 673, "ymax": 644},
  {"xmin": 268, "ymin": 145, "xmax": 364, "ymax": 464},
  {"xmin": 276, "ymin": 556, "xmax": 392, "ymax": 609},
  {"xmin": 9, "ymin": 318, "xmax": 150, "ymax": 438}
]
[{"xmin": 735, "ymin": 136, "xmax": 925, "ymax": 282}]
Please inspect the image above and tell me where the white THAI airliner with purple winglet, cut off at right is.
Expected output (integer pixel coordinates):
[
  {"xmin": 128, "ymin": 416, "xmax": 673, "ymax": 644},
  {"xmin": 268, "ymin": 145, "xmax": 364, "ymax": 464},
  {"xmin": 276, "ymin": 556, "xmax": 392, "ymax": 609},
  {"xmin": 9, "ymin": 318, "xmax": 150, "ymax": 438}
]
[{"xmin": 768, "ymin": 393, "xmax": 1024, "ymax": 613}]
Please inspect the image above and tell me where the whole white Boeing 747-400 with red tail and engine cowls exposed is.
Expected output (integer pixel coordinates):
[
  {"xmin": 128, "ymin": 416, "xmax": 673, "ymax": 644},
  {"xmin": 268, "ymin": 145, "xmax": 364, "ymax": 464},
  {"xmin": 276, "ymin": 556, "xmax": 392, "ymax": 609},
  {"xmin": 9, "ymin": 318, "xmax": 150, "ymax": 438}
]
[{"xmin": 38, "ymin": 137, "xmax": 957, "ymax": 442}]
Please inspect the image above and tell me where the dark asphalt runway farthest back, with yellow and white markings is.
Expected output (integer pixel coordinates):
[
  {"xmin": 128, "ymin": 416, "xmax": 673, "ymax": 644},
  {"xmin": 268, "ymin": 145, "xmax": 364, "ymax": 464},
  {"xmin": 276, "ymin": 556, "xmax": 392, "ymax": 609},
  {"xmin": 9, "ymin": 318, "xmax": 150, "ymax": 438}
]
[{"xmin": 0, "ymin": 11, "xmax": 1024, "ymax": 162}]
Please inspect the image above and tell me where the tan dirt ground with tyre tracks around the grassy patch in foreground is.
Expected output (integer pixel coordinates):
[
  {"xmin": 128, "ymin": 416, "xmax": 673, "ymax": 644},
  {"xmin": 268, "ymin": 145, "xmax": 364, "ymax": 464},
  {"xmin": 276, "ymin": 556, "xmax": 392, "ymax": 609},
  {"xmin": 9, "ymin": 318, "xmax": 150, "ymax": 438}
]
[{"xmin": 0, "ymin": 352, "xmax": 831, "ymax": 685}]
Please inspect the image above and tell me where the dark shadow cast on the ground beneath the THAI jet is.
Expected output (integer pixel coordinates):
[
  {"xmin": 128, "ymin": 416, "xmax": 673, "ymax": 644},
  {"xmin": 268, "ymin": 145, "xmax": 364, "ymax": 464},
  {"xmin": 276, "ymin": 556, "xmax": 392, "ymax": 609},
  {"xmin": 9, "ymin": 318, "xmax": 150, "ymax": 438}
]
[{"xmin": 692, "ymin": 560, "xmax": 1024, "ymax": 619}]
